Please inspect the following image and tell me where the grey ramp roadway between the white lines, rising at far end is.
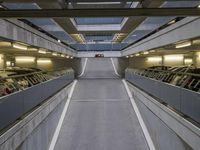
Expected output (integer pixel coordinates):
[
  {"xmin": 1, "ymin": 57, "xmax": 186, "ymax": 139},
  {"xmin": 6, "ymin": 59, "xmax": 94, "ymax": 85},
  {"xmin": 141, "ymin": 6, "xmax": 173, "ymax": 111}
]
[{"xmin": 50, "ymin": 58, "xmax": 149, "ymax": 150}]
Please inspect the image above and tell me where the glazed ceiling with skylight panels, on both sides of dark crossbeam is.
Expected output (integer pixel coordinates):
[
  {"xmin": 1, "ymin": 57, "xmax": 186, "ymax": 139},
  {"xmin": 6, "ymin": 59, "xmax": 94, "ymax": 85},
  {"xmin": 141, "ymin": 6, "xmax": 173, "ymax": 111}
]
[{"xmin": 2, "ymin": 0, "xmax": 200, "ymax": 51}]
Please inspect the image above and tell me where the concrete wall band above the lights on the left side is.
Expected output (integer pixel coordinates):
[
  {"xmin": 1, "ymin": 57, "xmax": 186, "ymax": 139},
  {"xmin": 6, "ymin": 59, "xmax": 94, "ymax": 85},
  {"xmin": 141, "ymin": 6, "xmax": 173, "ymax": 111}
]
[{"xmin": 0, "ymin": 19, "xmax": 76, "ymax": 56}]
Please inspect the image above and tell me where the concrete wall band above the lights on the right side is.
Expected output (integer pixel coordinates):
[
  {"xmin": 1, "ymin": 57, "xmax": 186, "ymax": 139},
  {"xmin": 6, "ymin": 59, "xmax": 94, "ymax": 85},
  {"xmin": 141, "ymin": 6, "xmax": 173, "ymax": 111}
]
[{"xmin": 122, "ymin": 17, "xmax": 200, "ymax": 56}]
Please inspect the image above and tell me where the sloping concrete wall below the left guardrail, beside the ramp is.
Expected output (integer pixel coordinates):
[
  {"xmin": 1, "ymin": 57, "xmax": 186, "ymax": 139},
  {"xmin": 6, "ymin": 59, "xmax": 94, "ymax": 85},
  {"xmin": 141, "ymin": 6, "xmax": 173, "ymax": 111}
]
[{"xmin": 0, "ymin": 84, "xmax": 71, "ymax": 150}]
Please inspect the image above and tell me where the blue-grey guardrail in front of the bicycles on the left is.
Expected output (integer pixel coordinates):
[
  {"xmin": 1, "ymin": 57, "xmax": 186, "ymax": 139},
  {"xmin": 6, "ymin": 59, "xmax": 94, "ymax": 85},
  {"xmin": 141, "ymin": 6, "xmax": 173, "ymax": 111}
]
[{"xmin": 0, "ymin": 69, "xmax": 74, "ymax": 130}]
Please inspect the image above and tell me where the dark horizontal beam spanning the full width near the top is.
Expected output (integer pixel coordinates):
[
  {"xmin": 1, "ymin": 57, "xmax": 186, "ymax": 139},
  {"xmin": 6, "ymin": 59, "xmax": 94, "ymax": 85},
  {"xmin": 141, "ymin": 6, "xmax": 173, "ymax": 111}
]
[{"xmin": 0, "ymin": 8, "xmax": 200, "ymax": 18}]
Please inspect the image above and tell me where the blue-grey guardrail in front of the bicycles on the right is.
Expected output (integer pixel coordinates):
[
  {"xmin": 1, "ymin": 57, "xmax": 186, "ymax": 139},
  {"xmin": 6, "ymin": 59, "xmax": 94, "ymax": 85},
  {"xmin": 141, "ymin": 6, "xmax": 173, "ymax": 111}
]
[{"xmin": 125, "ymin": 69, "xmax": 200, "ymax": 123}]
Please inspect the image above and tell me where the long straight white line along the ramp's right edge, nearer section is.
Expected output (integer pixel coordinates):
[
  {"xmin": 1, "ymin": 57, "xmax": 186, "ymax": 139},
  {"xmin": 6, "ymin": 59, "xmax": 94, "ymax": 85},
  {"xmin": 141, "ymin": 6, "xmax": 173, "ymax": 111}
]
[{"xmin": 122, "ymin": 79, "xmax": 156, "ymax": 150}]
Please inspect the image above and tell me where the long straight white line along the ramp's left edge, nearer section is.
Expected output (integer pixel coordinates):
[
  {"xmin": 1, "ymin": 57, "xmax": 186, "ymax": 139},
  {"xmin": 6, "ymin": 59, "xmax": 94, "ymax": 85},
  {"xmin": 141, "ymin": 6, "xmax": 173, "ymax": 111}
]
[{"xmin": 49, "ymin": 80, "xmax": 77, "ymax": 150}]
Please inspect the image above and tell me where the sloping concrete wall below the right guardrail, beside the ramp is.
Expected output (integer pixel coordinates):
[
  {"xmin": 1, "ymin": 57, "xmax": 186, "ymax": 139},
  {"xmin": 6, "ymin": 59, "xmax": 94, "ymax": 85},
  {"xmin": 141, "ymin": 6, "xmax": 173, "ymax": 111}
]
[{"xmin": 128, "ymin": 84, "xmax": 200, "ymax": 150}]
